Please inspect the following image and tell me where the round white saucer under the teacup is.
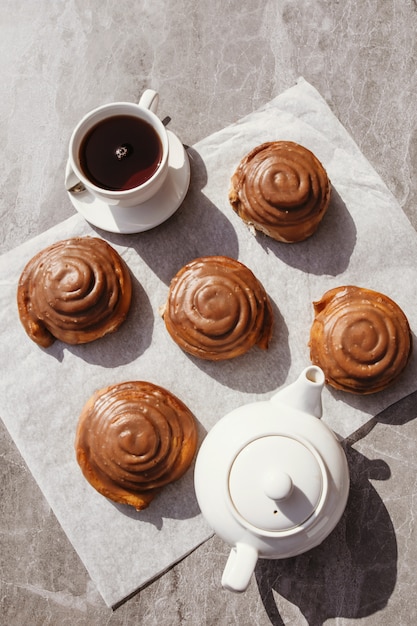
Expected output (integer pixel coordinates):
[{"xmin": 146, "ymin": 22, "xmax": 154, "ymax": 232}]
[{"xmin": 67, "ymin": 131, "xmax": 190, "ymax": 234}]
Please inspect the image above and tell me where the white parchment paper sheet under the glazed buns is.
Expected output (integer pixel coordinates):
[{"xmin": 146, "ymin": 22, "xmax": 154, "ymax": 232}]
[{"xmin": 0, "ymin": 79, "xmax": 417, "ymax": 605}]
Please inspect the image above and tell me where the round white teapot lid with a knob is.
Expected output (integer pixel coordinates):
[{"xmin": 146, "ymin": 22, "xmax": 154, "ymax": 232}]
[{"xmin": 228, "ymin": 434, "xmax": 327, "ymax": 532}]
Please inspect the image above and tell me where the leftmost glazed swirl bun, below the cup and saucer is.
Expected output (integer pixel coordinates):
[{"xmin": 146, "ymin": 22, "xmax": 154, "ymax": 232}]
[{"xmin": 17, "ymin": 237, "xmax": 132, "ymax": 348}]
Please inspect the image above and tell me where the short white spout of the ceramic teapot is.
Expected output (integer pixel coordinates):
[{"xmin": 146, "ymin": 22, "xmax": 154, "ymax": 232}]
[{"xmin": 271, "ymin": 365, "xmax": 325, "ymax": 418}]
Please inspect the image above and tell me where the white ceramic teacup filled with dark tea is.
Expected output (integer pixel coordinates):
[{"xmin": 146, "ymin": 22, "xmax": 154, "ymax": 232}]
[{"xmin": 65, "ymin": 89, "xmax": 169, "ymax": 207}]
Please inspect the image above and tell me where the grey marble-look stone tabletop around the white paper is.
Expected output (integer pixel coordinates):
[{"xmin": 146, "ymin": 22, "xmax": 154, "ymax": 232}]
[{"xmin": 0, "ymin": 0, "xmax": 417, "ymax": 626}]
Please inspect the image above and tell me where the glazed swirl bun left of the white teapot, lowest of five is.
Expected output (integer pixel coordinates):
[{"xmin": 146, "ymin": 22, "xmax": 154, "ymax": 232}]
[{"xmin": 75, "ymin": 381, "xmax": 197, "ymax": 511}]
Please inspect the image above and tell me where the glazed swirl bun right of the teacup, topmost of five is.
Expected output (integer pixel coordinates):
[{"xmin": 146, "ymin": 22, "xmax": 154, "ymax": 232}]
[{"xmin": 229, "ymin": 141, "xmax": 331, "ymax": 243}]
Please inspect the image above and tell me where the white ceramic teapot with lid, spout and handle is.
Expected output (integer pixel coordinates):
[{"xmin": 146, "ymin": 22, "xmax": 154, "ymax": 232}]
[{"xmin": 194, "ymin": 366, "xmax": 349, "ymax": 591}]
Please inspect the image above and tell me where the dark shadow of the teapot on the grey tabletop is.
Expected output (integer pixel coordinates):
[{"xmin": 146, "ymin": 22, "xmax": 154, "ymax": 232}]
[{"xmin": 255, "ymin": 446, "xmax": 398, "ymax": 626}]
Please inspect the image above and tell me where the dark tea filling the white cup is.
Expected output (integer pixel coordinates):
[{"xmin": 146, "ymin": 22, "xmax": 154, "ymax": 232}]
[{"xmin": 79, "ymin": 115, "xmax": 162, "ymax": 191}]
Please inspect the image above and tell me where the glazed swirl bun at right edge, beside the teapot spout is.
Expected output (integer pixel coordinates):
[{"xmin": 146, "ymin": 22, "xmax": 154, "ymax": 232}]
[{"xmin": 309, "ymin": 286, "xmax": 412, "ymax": 394}]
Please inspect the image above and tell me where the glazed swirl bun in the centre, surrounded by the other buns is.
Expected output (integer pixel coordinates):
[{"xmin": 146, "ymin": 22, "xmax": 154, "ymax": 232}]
[{"xmin": 162, "ymin": 256, "xmax": 272, "ymax": 361}]
